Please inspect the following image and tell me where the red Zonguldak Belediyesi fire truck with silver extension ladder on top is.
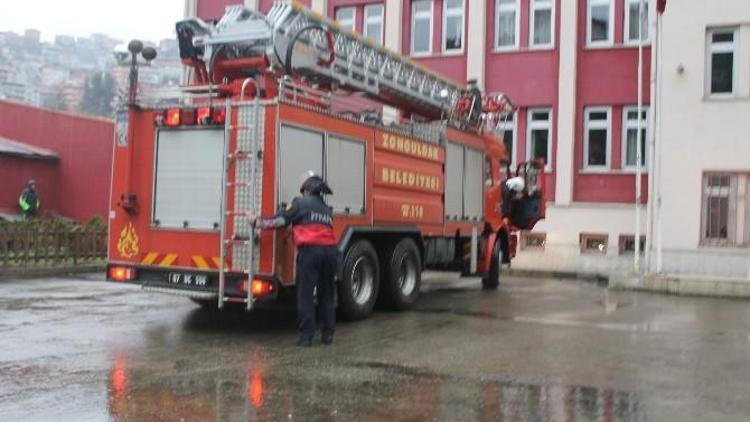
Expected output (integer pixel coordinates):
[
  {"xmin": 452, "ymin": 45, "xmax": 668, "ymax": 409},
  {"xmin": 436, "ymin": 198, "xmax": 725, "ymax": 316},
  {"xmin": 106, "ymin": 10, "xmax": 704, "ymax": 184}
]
[{"xmin": 108, "ymin": 1, "xmax": 544, "ymax": 319}]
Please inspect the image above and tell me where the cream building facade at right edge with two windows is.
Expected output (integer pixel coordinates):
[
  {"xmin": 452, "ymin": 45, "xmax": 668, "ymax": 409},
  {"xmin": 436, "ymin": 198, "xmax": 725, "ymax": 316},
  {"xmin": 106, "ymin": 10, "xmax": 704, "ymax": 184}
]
[{"xmin": 653, "ymin": 0, "xmax": 750, "ymax": 279}]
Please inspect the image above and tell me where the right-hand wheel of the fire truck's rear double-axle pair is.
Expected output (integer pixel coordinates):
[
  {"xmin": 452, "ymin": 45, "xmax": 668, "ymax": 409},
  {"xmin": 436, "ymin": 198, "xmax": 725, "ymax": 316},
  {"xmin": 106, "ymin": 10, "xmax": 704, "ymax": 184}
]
[{"xmin": 381, "ymin": 237, "xmax": 422, "ymax": 310}]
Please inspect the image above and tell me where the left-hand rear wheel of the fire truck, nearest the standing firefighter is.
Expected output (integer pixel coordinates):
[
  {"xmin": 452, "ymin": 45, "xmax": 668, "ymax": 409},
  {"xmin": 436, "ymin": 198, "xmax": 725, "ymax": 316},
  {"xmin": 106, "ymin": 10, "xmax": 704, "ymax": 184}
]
[{"xmin": 339, "ymin": 240, "xmax": 380, "ymax": 321}]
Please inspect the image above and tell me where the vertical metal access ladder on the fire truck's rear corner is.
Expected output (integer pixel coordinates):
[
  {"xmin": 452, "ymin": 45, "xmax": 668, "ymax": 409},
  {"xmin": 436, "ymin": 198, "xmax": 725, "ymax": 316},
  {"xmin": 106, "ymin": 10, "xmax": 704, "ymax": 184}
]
[{"xmin": 218, "ymin": 98, "xmax": 264, "ymax": 310}]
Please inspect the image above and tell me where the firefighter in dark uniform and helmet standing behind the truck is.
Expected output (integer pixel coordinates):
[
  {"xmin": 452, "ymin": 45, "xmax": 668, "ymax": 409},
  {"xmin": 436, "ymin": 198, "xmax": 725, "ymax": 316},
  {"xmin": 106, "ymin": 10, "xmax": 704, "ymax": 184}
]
[{"xmin": 253, "ymin": 171, "xmax": 338, "ymax": 347}]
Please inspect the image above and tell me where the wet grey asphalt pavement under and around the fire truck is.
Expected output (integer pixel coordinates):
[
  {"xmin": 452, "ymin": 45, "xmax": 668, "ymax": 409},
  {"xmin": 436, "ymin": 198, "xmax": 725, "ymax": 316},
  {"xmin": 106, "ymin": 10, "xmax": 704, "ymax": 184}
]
[{"xmin": 0, "ymin": 274, "xmax": 750, "ymax": 422}]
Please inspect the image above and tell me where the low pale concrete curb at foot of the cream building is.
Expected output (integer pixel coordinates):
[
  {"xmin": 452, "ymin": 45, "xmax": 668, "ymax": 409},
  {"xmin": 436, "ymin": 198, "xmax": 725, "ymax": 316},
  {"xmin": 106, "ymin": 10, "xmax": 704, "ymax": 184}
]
[{"xmin": 609, "ymin": 275, "xmax": 750, "ymax": 299}]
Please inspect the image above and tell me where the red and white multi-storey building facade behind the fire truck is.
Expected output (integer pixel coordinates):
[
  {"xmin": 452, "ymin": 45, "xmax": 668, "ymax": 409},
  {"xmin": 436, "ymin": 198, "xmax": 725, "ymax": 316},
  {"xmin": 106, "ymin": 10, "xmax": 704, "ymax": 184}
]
[{"xmin": 192, "ymin": 0, "xmax": 655, "ymax": 273}]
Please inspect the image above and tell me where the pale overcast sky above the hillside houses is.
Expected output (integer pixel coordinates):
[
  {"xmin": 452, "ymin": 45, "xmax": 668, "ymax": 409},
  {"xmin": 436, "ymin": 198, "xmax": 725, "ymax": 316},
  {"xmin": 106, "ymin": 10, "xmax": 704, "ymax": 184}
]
[{"xmin": 0, "ymin": 0, "xmax": 185, "ymax": 41}]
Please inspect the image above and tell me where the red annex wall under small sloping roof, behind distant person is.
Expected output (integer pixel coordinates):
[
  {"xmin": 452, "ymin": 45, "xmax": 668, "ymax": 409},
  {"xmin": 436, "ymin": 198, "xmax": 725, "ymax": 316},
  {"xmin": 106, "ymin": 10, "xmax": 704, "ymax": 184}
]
[{"xmin": 0, "ymin": 155, "xmax": 60, "ymax": 218}]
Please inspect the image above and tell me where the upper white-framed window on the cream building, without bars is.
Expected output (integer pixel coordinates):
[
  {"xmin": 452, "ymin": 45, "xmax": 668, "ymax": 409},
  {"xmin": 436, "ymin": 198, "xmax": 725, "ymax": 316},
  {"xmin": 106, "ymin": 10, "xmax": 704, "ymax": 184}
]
[{"xmin": 706, "ymin": 28, "xmax": 739, "ymax": 95}]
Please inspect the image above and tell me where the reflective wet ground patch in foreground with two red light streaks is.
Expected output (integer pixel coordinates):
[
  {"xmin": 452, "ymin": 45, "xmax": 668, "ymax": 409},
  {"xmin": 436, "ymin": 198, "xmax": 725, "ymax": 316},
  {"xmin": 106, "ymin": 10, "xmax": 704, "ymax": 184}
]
[{"xmin": 109, "ymin": 346, "xmax": 646, "ymax": 421}]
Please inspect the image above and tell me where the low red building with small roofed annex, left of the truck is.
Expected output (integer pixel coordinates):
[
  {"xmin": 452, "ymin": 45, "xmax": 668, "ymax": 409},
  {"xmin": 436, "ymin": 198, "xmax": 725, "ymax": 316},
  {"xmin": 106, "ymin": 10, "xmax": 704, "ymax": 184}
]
[{"xmin": 0, "ymin": 101, "xmax": 114, "ymax": 221}]
